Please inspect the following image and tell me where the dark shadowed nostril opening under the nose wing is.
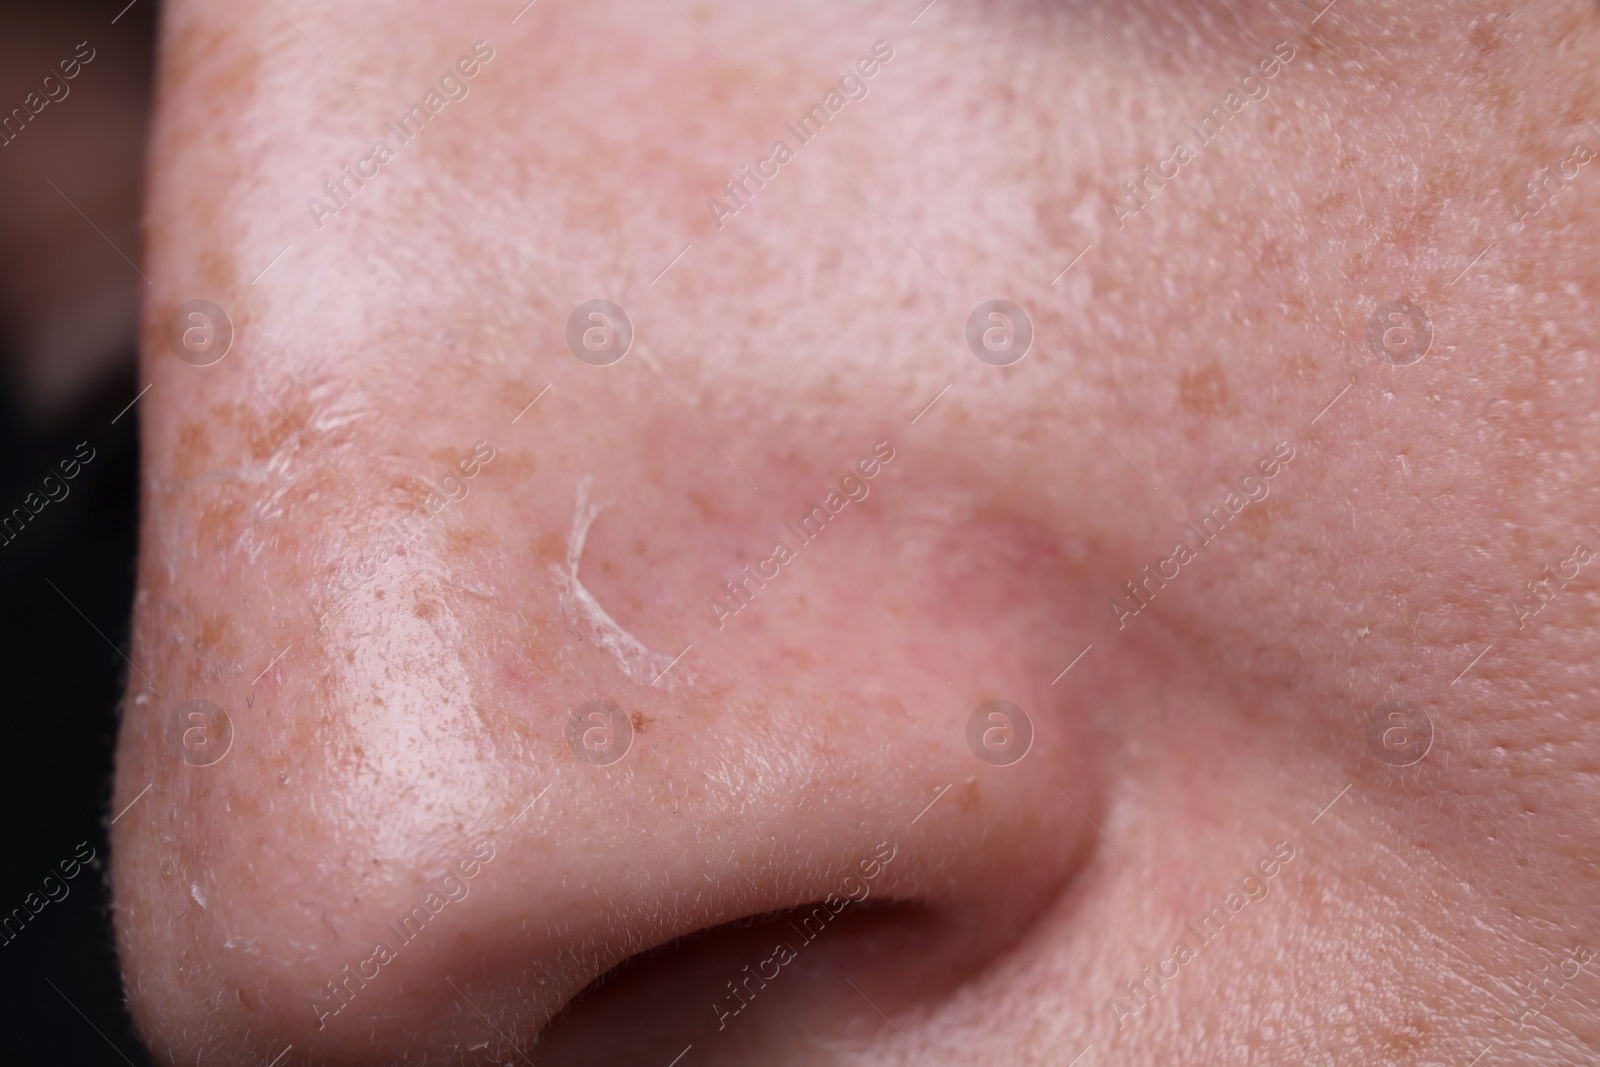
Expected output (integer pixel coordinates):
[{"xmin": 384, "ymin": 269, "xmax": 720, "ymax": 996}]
[{"xmin": 538, "ymin": 899, "xmax": 965, "ymax": 1067}]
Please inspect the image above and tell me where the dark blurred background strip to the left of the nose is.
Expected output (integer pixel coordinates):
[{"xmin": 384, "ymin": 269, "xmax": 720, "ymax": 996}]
[{"xmin": 0, "ymin": 0, "xmax": 157, "ymax": 1067}]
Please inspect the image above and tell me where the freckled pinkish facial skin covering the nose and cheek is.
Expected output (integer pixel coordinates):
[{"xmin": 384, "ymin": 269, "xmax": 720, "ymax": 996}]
[{"xmin": 110, "ymin": 0, "xmax": 1600, "ymax": 1065}]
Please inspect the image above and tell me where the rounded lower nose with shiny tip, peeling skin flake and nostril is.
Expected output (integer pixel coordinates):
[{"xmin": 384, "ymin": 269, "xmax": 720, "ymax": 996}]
[{"xmin": 114, "ymin": 463, "xmax": 1098, "ymax": 1064}]
